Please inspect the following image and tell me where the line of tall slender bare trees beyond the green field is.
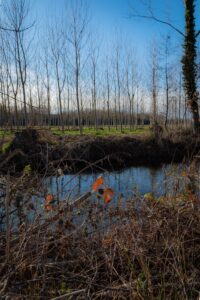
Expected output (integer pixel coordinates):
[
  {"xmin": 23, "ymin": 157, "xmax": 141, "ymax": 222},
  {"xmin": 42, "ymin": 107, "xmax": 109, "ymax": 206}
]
[{"xmin": 0, "ymin": 0, "xmax": 199, "ymax": 134}]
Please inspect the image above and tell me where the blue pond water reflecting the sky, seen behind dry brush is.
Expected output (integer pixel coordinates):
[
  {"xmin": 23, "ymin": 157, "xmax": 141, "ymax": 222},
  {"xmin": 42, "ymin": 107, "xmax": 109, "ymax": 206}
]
[{"xmin": 0, "ymin": 164, "xmax": 192, "ymax": 230}]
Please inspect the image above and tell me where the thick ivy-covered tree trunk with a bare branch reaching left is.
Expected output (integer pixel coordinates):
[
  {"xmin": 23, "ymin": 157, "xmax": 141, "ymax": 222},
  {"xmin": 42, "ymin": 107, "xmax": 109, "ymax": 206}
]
[{"xmin": 130, "ymin": 0, "xmax": 200, "ymax": 134}]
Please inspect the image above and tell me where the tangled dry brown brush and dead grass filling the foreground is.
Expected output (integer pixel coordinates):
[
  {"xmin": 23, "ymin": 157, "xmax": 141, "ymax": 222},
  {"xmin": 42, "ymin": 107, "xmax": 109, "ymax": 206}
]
[{"xmin": 0, "ymin": 175, "xmax": 200, "ymax": 299}]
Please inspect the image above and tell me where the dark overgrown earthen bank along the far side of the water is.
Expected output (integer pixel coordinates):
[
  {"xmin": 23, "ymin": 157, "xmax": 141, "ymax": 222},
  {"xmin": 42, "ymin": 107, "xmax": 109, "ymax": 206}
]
[{"xmin": 0, "ymin": 129, "xmax": 200, "ymax": 174}]
